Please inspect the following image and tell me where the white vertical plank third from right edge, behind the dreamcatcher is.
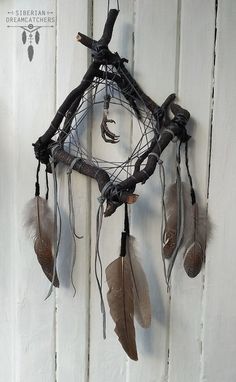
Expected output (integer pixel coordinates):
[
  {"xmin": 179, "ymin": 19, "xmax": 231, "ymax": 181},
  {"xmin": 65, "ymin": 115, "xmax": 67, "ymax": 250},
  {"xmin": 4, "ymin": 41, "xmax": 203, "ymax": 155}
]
[{"xmin": 128, "ymin": 0, "xmax": 177, "ymax": 382}]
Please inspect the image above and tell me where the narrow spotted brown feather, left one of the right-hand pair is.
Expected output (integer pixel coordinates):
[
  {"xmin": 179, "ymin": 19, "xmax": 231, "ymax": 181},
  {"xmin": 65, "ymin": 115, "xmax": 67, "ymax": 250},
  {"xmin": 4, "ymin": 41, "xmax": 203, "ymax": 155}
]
[{"xmin": 163, "ymin": 183, "xmax": 178, "ymax": 259}]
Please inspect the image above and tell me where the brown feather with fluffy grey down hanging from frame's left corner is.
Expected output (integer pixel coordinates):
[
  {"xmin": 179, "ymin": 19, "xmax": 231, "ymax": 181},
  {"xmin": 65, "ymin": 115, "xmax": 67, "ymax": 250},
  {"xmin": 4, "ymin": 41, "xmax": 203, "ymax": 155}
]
[{"xmin": 25, "ymin": 196, "xmax": 59, "ymax": 287}]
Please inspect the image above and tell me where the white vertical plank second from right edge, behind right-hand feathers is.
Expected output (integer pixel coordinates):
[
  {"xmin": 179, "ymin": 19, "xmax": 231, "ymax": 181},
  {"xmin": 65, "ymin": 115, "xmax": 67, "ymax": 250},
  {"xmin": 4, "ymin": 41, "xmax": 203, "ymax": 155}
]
[{"xmin": 169, "ymin": 0, "xmax": 215, "ymax": 382}]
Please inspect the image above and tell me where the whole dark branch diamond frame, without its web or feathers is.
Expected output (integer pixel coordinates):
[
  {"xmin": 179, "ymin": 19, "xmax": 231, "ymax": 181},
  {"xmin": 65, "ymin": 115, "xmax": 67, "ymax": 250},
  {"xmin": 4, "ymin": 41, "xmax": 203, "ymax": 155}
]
[{"xmin": 34, "ymin": 9, "xmax": 190, "ymax": 216}]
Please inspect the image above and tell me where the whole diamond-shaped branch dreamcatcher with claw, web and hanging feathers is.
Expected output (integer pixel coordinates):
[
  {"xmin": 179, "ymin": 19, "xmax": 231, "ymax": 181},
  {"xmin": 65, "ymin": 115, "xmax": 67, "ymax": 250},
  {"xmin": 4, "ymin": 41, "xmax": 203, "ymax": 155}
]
[{"xmin": 26, "ymin": 3, "xmax": 204, "ymax": 360}]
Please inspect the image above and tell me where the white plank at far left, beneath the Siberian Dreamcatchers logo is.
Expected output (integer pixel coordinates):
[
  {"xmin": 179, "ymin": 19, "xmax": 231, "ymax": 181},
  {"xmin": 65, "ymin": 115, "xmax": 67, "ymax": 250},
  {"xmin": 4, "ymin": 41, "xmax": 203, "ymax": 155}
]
[{"xmin": 11, "ymin": 0, "xmax": 56, "ymax": 382}]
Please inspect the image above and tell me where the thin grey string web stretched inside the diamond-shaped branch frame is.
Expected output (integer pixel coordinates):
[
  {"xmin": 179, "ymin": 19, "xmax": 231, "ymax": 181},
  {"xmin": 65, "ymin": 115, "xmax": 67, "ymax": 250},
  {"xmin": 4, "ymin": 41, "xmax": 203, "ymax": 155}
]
[{"xmin": 54, "ymin": 65, "xmax": 159, "ymax": 182}]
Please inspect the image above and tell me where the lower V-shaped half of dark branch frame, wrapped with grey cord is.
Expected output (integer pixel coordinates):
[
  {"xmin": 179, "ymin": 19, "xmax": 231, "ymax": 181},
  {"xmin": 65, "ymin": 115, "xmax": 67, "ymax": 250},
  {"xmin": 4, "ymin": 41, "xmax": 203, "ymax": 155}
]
[{"xmin": 42, "ymin": 104, "xmax": 190, "ymax": 216}]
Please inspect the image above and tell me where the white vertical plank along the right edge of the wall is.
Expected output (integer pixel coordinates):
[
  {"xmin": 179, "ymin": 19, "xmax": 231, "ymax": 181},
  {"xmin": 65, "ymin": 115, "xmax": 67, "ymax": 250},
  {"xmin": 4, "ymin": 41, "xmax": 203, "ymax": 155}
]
[{"xmin": 202, "ymin": 0, "xmax": 236, "ymax": 382}]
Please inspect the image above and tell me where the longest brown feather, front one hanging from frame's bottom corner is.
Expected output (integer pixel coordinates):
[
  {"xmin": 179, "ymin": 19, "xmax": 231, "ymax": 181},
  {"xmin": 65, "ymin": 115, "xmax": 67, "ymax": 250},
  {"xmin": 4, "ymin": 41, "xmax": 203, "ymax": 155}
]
[{"xmin": 106, "ymin": 256, "xmax": 138, "ymax": 361}]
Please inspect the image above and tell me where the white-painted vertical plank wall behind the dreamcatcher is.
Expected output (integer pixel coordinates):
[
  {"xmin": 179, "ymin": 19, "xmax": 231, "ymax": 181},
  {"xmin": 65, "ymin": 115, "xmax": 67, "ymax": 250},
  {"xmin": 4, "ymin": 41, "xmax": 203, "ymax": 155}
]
[{"xmin": 0, "ymin": 0, "xmax": 236, "ymax": 382}]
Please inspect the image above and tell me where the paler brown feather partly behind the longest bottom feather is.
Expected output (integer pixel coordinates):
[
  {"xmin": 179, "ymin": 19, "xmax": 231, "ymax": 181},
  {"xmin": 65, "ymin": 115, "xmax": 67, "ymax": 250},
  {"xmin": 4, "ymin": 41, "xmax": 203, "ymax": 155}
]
[{"xmin": 126, "ymin": 236, "xmax": 151, "ymax": 328}]
